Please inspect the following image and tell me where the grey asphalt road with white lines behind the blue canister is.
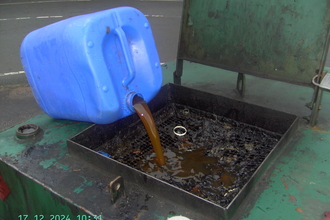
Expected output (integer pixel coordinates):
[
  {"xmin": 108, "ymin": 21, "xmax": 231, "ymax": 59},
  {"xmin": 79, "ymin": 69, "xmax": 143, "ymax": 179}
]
[{"xmin": 0, "ymin": 0, "xmax": 183, "ymax": 131}]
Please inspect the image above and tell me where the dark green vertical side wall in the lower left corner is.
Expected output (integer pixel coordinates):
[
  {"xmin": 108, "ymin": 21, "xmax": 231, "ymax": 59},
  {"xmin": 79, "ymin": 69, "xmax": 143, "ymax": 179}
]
[{"xmin": 0, "ymin": 162, "xmax": 86, "ymax": 220}]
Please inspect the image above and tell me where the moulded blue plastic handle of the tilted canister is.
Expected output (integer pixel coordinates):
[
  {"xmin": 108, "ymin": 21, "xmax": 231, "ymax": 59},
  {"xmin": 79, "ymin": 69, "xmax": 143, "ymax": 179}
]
[{"xmin": 113, "ymin": 13, "xmax": 135, "ymax": 87}]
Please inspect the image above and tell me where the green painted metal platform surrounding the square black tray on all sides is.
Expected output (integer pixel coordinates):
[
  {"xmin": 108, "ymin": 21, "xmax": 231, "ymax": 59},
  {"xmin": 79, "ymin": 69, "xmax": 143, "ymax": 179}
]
[{"xmin": 0, "ymin": 62, "xmax": 330, "ymax": 220}]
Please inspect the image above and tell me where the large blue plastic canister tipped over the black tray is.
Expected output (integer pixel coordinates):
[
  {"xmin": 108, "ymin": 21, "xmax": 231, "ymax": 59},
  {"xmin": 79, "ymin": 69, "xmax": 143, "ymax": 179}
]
[{"xmin": 21, "ymin": 7, "xmax": 162, "ymax": 124}]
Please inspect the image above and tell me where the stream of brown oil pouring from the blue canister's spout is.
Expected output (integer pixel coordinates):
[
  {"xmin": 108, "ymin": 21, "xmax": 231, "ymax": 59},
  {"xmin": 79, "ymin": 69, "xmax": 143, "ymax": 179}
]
[{"xmin": 133, "ymin": 95, "xmax": 165, "ymax": 166}]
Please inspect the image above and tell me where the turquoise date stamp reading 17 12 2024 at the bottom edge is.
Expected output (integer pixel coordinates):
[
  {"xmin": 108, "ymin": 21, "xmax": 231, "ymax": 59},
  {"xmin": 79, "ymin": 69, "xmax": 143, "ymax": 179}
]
[{"xmin": 18, "ymin": 215, "xmax": 102, "ymax": 220}]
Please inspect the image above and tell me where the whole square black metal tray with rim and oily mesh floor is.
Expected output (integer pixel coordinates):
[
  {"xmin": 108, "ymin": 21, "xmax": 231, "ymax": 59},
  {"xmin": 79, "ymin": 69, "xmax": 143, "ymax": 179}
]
[{"xmin": 68, "ymin": 84, "xmax": 297, "ymax": 219}]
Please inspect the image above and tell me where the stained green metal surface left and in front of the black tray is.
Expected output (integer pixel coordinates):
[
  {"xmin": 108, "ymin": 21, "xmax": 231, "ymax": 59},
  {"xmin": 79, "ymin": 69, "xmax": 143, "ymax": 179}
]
[{"xmin": 0, "ymin": 114, "xmax": 210, "ymax": 220}]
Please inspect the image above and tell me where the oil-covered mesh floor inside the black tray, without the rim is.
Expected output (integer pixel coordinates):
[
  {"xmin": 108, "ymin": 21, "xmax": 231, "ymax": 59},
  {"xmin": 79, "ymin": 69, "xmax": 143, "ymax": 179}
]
[{"xmin": 99, "ymin": 104, "xmax": 281, "ymax": 207}]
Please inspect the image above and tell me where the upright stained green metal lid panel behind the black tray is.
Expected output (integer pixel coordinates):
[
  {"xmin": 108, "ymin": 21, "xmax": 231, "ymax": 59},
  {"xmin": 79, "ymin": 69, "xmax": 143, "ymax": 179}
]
[{"xmin": 178, "ymin": 0, "xmax": 330, "ymax": 85}]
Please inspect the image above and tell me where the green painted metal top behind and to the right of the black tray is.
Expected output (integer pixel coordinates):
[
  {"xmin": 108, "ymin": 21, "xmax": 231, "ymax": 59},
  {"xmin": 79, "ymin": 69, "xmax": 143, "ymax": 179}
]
[{"xmin": 168, "ymin": 62, "xmax": 330, "ymax": 220}]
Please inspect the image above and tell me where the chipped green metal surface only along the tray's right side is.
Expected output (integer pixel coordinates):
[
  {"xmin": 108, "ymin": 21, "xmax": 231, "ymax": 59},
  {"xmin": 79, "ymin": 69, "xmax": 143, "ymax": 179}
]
[{"xmin": 244, "ymin": 127, "xmax": 330, "ymax": 220}]
